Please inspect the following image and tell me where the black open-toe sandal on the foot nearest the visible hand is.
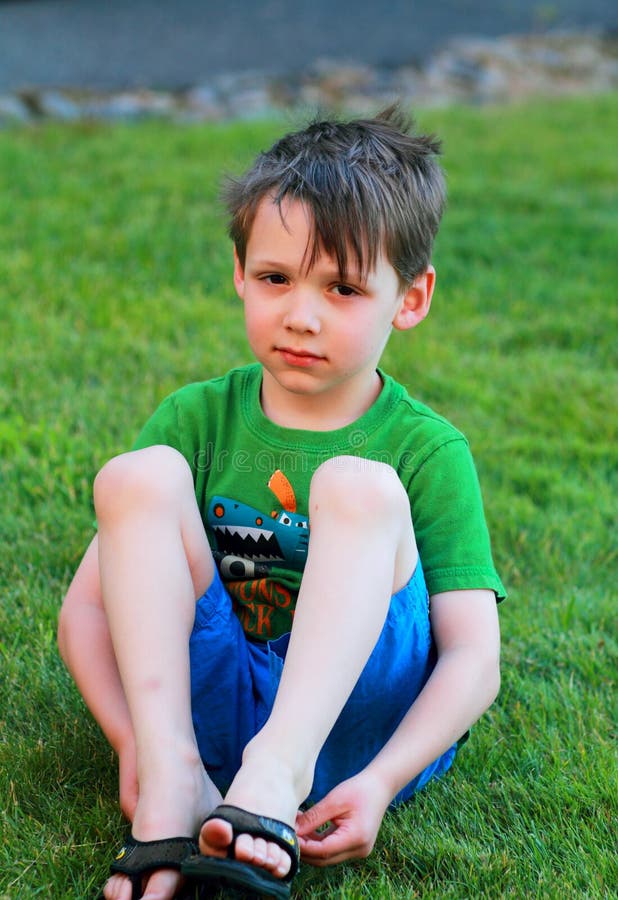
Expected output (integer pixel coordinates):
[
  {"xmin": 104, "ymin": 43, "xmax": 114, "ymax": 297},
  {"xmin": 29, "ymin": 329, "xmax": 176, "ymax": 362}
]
[{"xmin": 180, "ymin": 805, "xmax": 300, "ymax": 900}]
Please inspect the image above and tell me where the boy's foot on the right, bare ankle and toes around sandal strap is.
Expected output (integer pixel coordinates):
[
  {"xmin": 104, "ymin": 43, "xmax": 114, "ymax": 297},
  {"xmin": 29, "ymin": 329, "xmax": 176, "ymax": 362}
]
[{"xmin": 199, "ymin": 748, "xmax": 310, "ymax": 878}]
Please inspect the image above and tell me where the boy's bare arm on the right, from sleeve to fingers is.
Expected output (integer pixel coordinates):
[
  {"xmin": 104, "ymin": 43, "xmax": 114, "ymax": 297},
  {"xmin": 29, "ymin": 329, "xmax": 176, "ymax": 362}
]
[{"xmin": 296, "ymin": 590, "xmax": 500, "ymax": 866}]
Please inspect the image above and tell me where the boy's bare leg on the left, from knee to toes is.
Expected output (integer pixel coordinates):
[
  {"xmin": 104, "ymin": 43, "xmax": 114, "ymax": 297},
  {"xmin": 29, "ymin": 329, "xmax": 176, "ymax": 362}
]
[{"xmin": 95, "ymin": 447, "xmax": 220, "ymax": 898}]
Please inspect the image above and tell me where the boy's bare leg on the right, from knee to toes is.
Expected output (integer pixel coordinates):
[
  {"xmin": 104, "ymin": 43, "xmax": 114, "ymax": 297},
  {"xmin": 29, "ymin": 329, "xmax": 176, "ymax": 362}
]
[{"xmin": 200, "ymin": 457, "xmax": 417, "ymax": 875}]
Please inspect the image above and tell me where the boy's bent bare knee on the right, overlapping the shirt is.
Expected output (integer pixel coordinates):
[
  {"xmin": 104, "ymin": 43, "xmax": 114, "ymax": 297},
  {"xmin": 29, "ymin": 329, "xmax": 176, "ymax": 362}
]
[{"xmin": 309, "ymin": 456, "xmax": 410, "ymax": 524}]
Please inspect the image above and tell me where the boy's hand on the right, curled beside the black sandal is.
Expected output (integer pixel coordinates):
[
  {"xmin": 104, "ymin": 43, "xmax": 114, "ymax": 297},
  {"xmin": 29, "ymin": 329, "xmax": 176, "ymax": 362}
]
[{"xmin": 296, "ymin": 770, "xmax": 392, "ymax": 866}]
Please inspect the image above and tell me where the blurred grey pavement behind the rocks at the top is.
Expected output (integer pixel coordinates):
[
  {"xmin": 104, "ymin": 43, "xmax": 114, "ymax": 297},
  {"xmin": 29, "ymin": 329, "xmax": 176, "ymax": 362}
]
[{"xmin": 0, "ymin": 0, "xmax": 618, "ymax": 91}]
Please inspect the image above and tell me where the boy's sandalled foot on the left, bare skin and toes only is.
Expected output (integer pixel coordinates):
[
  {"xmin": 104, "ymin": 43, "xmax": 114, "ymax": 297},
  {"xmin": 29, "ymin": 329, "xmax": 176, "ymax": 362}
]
[{"xmin": 103, "ymin": 748, "xmax": 221, "ymax": 900}]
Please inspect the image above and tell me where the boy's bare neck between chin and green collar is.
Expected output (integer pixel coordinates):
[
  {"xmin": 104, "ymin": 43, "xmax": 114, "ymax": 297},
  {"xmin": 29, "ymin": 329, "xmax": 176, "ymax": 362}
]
[{"xmin": 260, "ymin": 369, "xmax": 383, "ymax": 431}]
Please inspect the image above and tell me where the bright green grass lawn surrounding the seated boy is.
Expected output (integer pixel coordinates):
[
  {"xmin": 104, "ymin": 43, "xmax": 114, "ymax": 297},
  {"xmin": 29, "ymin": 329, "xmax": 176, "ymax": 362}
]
[{"xmin": 0, "ymin": 96, "xmax": 618, "ymax": 900}]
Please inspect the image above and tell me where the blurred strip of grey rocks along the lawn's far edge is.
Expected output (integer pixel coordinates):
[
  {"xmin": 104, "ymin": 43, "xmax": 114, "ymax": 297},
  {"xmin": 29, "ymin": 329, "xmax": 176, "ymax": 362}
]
[{"xmin": 0, "ymin": 32, "xmax": 618, "ymax": 124}]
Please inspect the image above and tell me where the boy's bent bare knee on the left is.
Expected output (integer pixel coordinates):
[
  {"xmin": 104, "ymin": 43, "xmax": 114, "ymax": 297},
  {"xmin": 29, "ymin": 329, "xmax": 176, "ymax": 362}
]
[{"xmin": 94, "ymin": 445, "xmax": 193, "ymax": 519}]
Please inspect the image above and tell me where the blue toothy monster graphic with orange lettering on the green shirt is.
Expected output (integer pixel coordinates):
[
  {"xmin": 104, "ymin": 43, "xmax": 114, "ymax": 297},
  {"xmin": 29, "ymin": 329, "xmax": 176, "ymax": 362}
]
[{"xmin": 208, "ymin": 469, "xmax": 309, "ymax": 640}]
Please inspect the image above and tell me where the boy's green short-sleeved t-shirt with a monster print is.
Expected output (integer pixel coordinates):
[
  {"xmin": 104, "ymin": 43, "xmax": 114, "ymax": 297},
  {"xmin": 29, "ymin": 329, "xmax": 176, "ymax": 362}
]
[{"xmin": 134, "ymin": 364, "xmax": 505, "ymax": 640}]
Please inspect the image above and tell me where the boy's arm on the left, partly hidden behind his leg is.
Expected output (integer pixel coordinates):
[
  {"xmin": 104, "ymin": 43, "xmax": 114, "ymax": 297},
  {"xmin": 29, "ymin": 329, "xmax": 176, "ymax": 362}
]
[{"xmin": 58, "ymin": 535, "xmax": 137, "ymax": 819}]
